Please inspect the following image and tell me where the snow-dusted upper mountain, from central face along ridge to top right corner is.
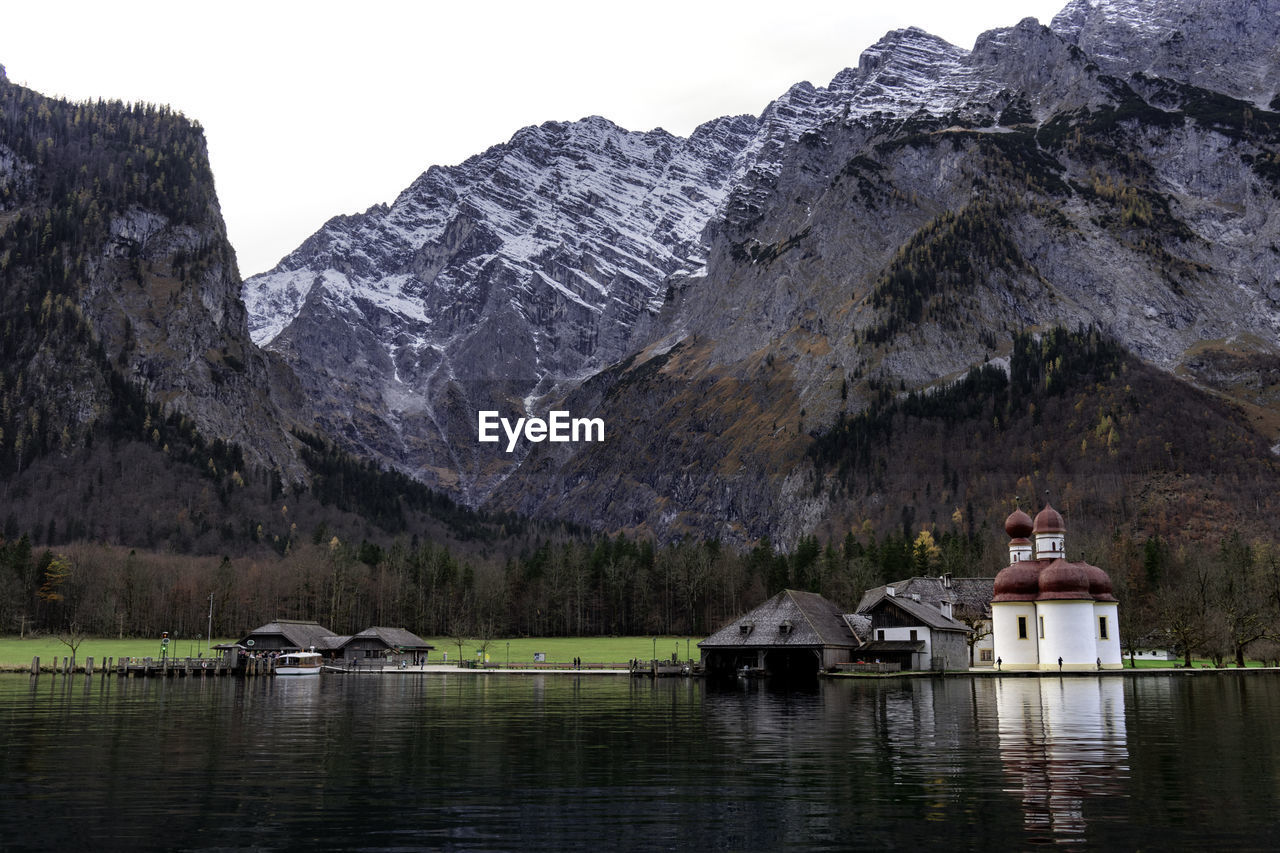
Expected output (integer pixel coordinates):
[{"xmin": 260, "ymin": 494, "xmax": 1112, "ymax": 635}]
[{"xmin": 243, "ymin": 0, "xmax": 1280, "ymax": 501}]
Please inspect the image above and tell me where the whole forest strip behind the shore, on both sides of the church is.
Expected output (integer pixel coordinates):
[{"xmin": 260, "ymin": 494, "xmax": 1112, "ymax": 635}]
[{"xmin": 0, "ymin": 519, "xmax": 1280, "ymax": 666}]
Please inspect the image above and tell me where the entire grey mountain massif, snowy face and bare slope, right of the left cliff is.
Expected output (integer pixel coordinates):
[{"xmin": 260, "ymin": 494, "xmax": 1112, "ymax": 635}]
[{"xmin": 244, "ymin": 0, "xmax": 1280, "ymax": 542}]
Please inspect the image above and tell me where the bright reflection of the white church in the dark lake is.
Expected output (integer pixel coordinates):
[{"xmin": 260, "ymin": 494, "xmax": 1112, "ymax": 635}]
[{"xmin": 995, "ymin": 678, "xmax": 1129, "ymax": 841}]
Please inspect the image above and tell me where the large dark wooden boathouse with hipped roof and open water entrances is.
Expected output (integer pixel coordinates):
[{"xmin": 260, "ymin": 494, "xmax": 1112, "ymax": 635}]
[{"xmin": 698, "ymin": 589, "xmax": 860, "ymax": 676}]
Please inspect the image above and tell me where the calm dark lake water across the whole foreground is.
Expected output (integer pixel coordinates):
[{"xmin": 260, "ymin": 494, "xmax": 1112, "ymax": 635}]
[{"xmin": 0, "ymin": 674, "xmax": 1280, "ymax": 853}]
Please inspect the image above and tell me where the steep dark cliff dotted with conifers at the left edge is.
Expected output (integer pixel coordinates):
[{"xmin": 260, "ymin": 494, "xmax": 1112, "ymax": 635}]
[{"xmin": 0, "ymin": 69, "xmax": 301, "ymax": 479}]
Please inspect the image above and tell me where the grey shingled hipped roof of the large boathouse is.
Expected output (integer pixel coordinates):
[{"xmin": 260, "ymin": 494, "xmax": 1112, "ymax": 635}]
[{"xmin": 698, "ymin": 589, "xmax": 859, "ymax": 649}]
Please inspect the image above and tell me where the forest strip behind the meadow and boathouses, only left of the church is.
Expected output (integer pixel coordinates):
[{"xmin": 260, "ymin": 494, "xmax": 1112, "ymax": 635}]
[{"xmin": 0, "ymin": 514, "xmax": 983, "ymax": 637}]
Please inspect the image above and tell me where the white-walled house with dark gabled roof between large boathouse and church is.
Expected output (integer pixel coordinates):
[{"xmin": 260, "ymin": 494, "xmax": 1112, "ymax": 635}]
[{"xmin": 858, "ymin": 587, "xmax": 970, "ymax": 670}]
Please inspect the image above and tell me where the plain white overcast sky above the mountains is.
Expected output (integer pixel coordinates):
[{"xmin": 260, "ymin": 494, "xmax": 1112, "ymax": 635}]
[{"xmin": 0, "ymin": 0, "xmax": 1066, "ymax": 277}]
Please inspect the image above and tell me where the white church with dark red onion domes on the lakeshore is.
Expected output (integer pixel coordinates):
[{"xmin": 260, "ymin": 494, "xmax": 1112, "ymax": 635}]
[{"xmin": 991, "ymin": 503, "xmax": 1123, "ymax": 671}]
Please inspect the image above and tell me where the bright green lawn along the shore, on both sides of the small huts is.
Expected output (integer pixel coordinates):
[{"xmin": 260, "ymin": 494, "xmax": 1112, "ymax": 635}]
[{"xmin": 0, "ymin": 635, "xmax": 703, "ymax": 670}]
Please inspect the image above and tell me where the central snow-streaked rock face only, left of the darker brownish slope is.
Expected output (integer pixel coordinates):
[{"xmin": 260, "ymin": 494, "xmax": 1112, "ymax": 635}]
[{"xmin": 244, "ymin": 118, "xmax": 758, "ymax": 498}]
